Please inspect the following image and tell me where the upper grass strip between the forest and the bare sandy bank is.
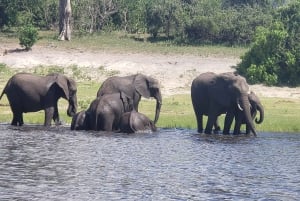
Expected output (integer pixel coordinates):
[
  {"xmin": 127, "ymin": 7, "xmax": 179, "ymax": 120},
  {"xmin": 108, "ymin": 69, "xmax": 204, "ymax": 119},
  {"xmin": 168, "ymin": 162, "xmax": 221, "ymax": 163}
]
[{"xmin": 0, "ymin": 31, "xmax": 247, "ymax": 57}]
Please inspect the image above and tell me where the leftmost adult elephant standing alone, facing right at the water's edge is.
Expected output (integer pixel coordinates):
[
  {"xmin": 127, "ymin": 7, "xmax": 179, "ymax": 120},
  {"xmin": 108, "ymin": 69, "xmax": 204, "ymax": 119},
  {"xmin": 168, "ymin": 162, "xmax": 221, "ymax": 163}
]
[{"xmin": 0, "ymin": 73, "xmax": 77, "ymax": 126}]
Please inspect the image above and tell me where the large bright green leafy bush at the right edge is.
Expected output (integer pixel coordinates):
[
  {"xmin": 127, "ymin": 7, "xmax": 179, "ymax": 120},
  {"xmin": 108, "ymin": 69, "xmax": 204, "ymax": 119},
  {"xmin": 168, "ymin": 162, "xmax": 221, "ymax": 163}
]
[{"xmin": 237, "ymin": 1, "xmax": 300, "ymax": 86}]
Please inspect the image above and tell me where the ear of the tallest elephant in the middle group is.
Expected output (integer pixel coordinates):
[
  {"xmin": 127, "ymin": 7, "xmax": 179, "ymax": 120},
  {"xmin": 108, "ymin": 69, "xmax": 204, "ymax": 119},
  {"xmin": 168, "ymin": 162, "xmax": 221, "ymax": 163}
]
[{"xmin": 134, "ymin": 74, "xmax": 153, "ymax": 98}]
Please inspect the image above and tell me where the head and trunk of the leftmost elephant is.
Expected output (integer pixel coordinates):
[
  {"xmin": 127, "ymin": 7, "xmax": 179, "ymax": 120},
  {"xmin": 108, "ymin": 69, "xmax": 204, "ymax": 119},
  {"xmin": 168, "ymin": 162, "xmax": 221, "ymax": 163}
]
[{"xmin": 48, "ymin": 73, "xmax": 77, "ymax": 117}]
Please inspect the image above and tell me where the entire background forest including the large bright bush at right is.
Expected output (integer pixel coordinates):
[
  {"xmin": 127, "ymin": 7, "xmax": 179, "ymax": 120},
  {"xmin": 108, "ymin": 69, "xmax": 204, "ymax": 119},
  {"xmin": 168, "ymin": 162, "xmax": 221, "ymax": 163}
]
[{"xmin": 0, "ymin": 0, "xmax": 300, "ymax": 86}]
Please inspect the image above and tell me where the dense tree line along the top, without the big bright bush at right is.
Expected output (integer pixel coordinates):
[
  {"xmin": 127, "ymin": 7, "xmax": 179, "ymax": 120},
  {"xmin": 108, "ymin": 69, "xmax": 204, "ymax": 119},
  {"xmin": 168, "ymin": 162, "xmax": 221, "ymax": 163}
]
[{"xmin": 0, "ymin": 0, "xmax": 287, "ymax": 45}]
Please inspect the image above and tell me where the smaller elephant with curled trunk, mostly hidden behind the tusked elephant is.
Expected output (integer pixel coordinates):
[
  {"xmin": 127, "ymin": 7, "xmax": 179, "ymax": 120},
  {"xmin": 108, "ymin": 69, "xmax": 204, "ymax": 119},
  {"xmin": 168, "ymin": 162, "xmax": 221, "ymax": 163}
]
[{"xmin": 224, "ymin": 91, "xmax": 264, "ymax": 135}]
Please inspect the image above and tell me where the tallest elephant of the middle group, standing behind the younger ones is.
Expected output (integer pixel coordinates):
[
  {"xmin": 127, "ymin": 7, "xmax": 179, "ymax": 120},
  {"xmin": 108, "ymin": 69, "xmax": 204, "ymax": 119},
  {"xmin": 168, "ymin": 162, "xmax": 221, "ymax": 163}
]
[{"xmin": 97, "ymin": 74, "xmax": 162, "ymax": 123}]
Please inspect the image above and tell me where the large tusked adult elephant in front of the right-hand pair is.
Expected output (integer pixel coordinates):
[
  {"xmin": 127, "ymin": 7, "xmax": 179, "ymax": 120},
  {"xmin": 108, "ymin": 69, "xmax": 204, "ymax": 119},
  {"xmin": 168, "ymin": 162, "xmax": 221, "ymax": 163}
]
[{"xmin": 191, "ymin": 72, "xmax": 256, "ymax": 135}]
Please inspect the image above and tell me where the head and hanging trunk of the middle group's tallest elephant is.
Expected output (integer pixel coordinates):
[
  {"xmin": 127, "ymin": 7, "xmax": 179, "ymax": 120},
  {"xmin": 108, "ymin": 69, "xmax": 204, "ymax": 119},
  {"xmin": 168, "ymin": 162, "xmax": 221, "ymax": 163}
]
[{"xmin": 134, "ymin": 74, "xmax": 162, "ymax": 124}]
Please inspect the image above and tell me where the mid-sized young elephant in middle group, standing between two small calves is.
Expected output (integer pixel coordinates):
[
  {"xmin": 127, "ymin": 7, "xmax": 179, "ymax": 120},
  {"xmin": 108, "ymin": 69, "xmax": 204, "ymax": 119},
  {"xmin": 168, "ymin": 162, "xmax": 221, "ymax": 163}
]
[{"xmin": 87, "ymin": 92, "xmax": 133, "ymax": 131}]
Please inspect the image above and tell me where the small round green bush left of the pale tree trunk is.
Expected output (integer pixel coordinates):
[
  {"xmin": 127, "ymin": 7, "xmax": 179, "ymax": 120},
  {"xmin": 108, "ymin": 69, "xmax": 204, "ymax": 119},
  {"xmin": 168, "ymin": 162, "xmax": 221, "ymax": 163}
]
[{"xmin": 19, "ymin": 25, "xmax": 38, "ymax": 50}]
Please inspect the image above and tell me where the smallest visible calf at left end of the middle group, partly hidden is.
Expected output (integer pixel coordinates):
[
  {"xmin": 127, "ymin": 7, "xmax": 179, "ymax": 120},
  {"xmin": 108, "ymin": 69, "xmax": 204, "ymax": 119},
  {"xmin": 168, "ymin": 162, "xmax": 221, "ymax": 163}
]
[{"xmin": 71, "ymin": 110, "xmax": 91, "ymax": 130}]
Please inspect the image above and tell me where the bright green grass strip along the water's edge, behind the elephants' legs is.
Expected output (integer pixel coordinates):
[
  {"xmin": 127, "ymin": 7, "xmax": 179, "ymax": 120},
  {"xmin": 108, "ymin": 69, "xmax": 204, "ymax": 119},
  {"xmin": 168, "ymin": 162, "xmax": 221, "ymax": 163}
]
[{"xmin": 0, "ymin": 78, "xmax": 300, "ymax": 133}]
